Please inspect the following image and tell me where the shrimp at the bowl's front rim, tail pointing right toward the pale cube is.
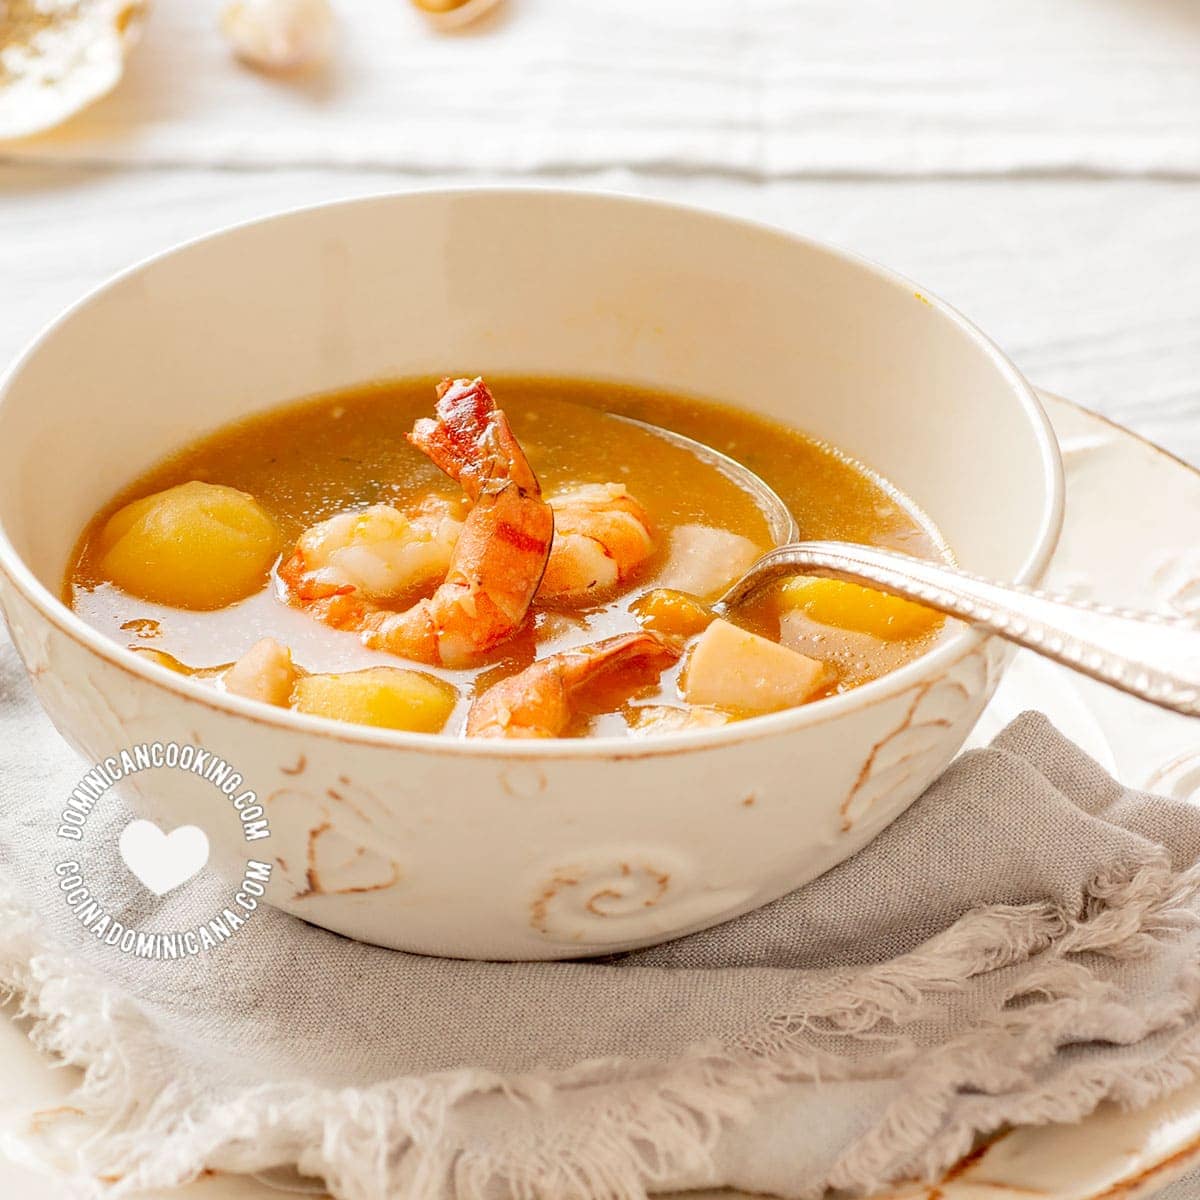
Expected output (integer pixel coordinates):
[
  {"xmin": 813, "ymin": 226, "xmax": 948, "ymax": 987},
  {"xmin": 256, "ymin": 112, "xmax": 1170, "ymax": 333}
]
[{"xmin": 467, "ymin": 631, "xmax": 679, "ymax": 738}]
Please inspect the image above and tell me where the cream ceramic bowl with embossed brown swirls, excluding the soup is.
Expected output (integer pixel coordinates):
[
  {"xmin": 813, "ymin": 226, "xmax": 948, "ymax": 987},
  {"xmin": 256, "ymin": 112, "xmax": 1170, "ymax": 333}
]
[{"xmin": 0, "ymin": 190, "xmax": 1062, "ymax": 959}]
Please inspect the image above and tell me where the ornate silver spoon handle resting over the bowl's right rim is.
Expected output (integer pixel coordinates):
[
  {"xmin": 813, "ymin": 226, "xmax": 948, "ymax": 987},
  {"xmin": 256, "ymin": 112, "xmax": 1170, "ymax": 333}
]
[{"xmin": 716, "ymin": 541, "xmax": 1200, "ymax": 716}]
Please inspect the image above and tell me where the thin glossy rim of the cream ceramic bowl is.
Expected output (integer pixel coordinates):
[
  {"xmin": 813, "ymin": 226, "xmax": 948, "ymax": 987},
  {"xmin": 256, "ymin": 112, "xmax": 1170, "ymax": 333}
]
[{"xmin": 0, "ymin": 185, "xmax": 1066, "ymax": 761}]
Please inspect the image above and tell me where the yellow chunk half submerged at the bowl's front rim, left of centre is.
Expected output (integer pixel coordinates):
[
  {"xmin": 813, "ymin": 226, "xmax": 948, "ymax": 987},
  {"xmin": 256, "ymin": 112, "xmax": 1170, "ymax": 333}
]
[{"xmin": 292, "ymin": 667, "xmax": 458, "ymax": 733}]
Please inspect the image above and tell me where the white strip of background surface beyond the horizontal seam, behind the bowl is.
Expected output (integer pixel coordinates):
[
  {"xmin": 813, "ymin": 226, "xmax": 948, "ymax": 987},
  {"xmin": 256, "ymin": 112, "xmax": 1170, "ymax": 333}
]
[{"xmin": 14, "ymin": 0, "xmax": 1200, "ymax": 175}]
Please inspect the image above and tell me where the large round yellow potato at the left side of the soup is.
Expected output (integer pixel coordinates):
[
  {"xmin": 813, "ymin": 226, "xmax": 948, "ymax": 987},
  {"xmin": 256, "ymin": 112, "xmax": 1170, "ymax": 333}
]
[{"xmin": 100, "ymin": 480, "xmax": 280, "ymax": 610}]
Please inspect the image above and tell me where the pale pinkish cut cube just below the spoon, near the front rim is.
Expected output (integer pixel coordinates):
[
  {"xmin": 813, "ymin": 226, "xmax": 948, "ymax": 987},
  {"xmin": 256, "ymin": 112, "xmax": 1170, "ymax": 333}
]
[{"xmin": 684, "ymin": 620, "xmax": 828, "ymax": 714}]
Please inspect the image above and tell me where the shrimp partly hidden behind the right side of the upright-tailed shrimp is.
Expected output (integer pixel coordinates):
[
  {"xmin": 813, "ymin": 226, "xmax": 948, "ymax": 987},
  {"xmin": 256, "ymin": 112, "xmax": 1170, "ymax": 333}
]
[{"xmin": 538, "ymin": 484, "xmax": 655, "ymax": 602}]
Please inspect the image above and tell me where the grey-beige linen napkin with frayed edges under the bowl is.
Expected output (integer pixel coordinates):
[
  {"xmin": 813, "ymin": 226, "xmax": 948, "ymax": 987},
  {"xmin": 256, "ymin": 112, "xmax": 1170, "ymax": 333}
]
[{"xmin": 0, "ymin": 647, "xmax": 1200, "ymax": 1200}]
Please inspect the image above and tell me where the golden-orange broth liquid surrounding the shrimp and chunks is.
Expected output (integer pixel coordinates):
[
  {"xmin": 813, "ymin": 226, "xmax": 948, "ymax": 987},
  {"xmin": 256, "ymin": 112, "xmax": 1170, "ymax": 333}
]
[{"xmin": 64, "ymin": 377, "xmax": 947, "ymax": 734}]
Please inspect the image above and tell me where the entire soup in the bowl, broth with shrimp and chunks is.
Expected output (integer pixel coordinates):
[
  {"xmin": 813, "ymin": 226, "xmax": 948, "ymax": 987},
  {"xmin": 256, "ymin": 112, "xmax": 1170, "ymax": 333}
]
[{"xmin": 64, "ymin": 376, "xmax": 949, "ymax": 740}]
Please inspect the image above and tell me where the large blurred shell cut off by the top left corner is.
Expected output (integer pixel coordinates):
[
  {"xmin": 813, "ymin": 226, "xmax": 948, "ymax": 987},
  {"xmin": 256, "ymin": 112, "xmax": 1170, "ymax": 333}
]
[{"xmin": 0, "ymin": 0, "xmax": 146, "ymax": 138}]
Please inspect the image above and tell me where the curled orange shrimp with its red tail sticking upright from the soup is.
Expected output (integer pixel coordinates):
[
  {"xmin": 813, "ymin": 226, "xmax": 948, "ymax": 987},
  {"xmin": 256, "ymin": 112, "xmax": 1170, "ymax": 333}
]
[{"xmin": 278, "ymin": 378, "xmax": 554, "ymax": 667}]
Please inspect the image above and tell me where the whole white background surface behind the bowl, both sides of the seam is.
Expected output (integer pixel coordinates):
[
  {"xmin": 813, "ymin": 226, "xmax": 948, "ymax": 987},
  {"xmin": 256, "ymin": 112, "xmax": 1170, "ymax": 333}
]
[{"xmin": 0, "ymin": 0, "xmax": 1200, "ymax": 1200}]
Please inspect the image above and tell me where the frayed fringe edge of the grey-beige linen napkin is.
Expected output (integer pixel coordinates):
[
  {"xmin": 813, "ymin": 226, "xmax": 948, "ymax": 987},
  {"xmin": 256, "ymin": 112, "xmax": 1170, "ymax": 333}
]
[{"xmin": 0, "ymin": 753, "xmax": 1200, "ymax": 1200}]
